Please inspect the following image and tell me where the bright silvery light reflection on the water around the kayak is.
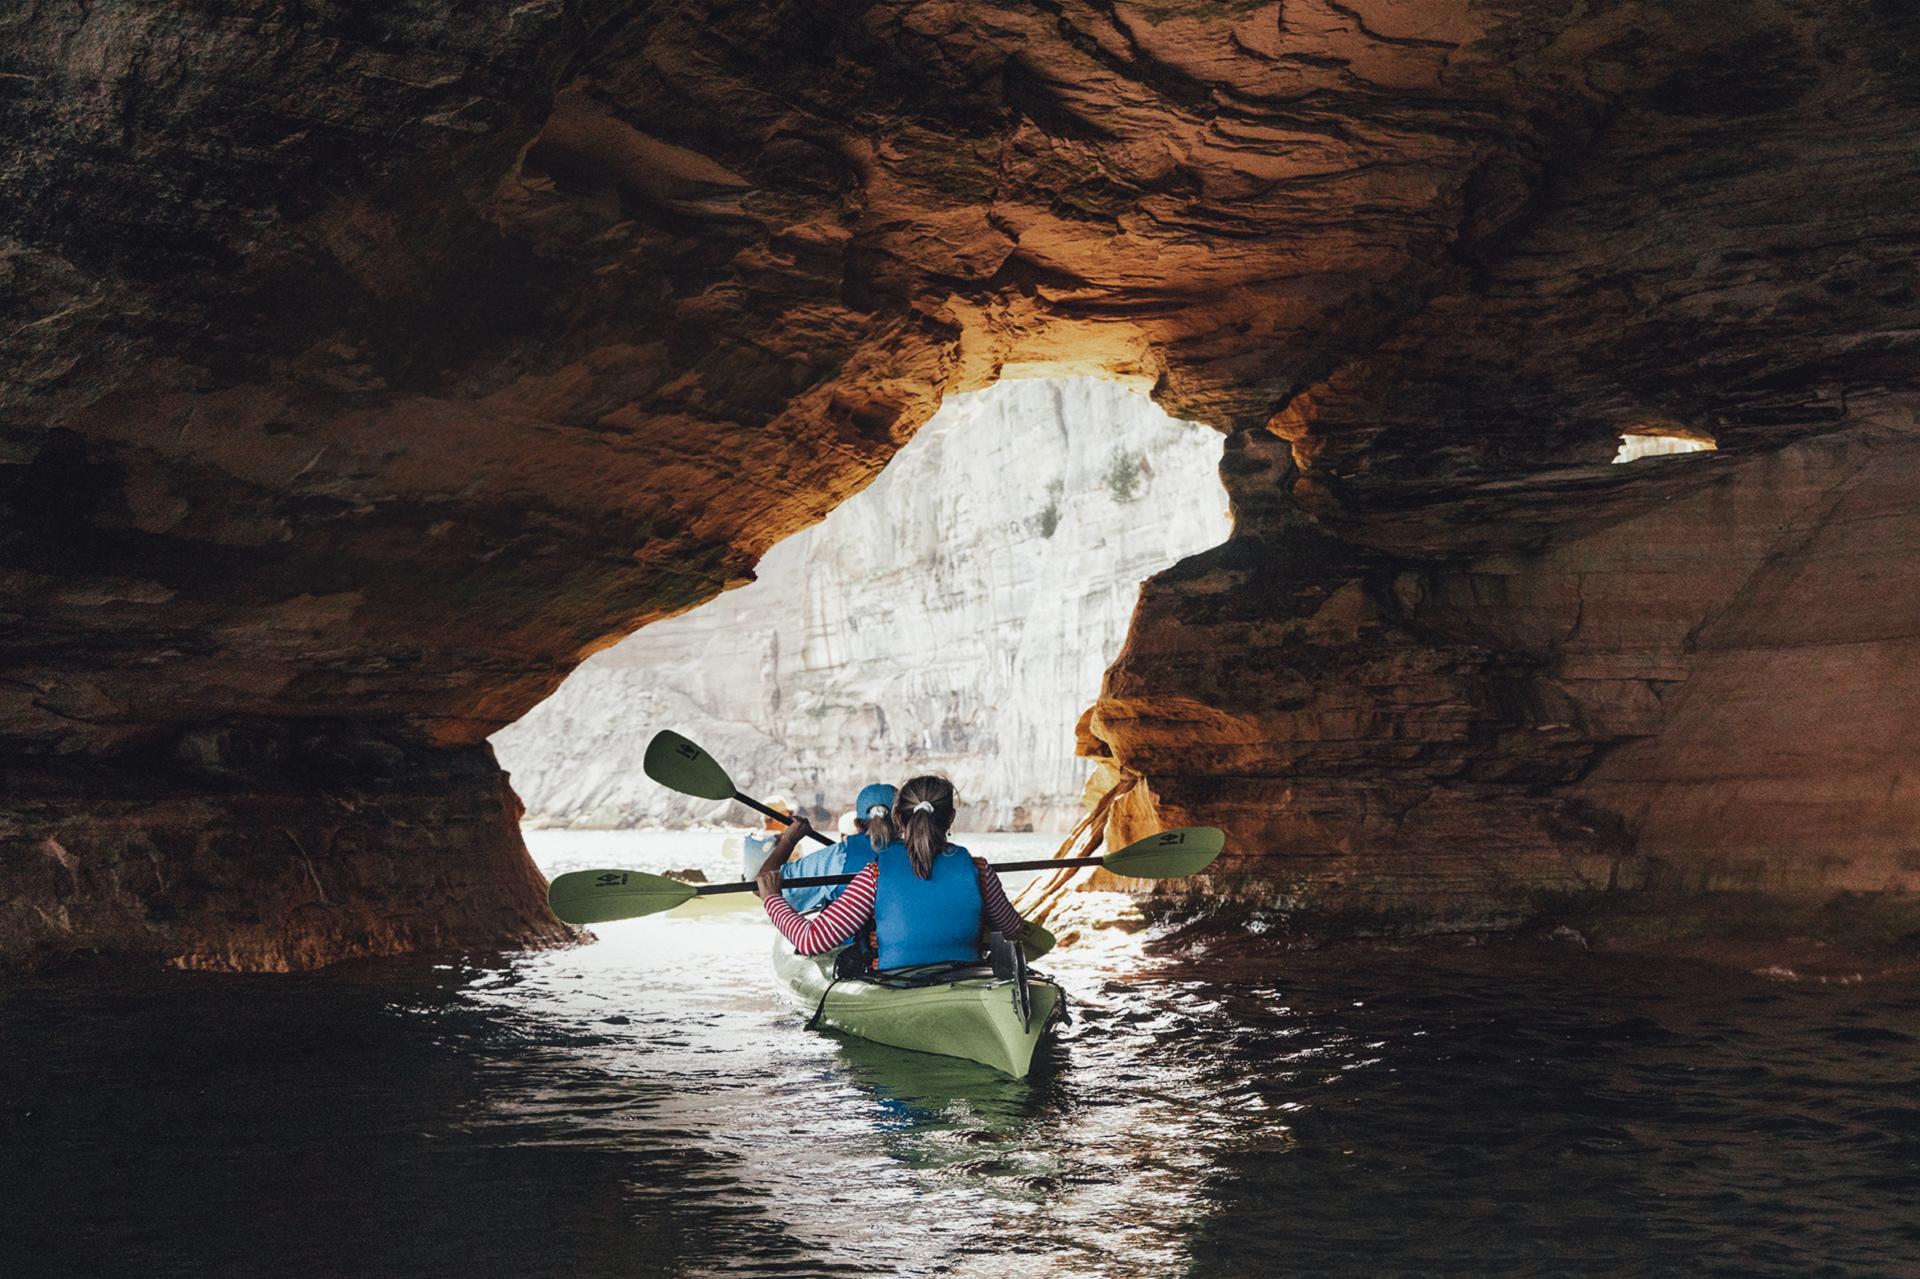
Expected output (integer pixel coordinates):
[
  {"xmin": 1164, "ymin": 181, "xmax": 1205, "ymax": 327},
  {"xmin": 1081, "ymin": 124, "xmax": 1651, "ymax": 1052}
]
[{"xmin": 447, "ymin": 914, "xmax": 1235, "ymax": 1275}]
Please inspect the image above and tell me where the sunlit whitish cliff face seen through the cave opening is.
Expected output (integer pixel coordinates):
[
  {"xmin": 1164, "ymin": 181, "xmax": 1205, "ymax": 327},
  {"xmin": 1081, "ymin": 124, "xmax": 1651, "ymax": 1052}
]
[{"xmin": 493, "ymin": 378, "xmax": 1229, "ymax": 830}]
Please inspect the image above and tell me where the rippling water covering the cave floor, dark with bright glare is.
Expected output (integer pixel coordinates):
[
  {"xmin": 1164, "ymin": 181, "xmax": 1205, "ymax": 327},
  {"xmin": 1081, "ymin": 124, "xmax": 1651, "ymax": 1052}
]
[{"xmin": 0, "ymin": 835, "xmax": 1920, "ymax": 1279}]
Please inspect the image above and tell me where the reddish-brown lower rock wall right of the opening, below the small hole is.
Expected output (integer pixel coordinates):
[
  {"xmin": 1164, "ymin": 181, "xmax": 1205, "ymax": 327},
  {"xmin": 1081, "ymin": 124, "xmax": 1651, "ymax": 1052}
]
[{"xmin": 1091, "ymin": 430, "xmax": 1920, "ymax": 931}]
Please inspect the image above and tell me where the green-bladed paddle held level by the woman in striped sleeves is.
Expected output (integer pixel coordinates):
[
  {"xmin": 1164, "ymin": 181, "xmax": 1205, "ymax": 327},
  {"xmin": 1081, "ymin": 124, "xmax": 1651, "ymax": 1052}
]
[{"xmin": 547, "ymin": 821, "xmax": 1227, "ymax": 921}]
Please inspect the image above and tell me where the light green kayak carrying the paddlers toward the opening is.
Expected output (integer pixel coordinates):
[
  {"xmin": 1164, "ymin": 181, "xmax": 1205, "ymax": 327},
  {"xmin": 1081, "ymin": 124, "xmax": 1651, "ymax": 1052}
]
[{"xmin": 774, "ymin": 937, "xmax": 1060, "ymax": 1079}]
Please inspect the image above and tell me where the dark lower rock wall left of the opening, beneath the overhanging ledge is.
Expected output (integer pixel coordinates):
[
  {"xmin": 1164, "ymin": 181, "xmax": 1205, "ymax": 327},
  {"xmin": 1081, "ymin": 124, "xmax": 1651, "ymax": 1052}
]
[{"xmin": 0, "ymin": 722, "xmax": 574, "ymax": 970}]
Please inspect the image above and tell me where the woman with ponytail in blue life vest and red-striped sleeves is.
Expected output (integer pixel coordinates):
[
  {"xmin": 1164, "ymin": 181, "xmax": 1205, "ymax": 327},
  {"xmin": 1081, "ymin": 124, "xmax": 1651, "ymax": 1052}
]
[{"xmin": 758, "ymin": 776, "xmax": 1025, "ymax": 970}]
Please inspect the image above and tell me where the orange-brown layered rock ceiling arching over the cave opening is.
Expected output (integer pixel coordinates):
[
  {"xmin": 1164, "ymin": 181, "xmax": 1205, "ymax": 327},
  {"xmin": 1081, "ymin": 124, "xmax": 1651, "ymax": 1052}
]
[{"xmin": 0, "ymin": 0, "xmax": 1920, "ymax": 775}]
